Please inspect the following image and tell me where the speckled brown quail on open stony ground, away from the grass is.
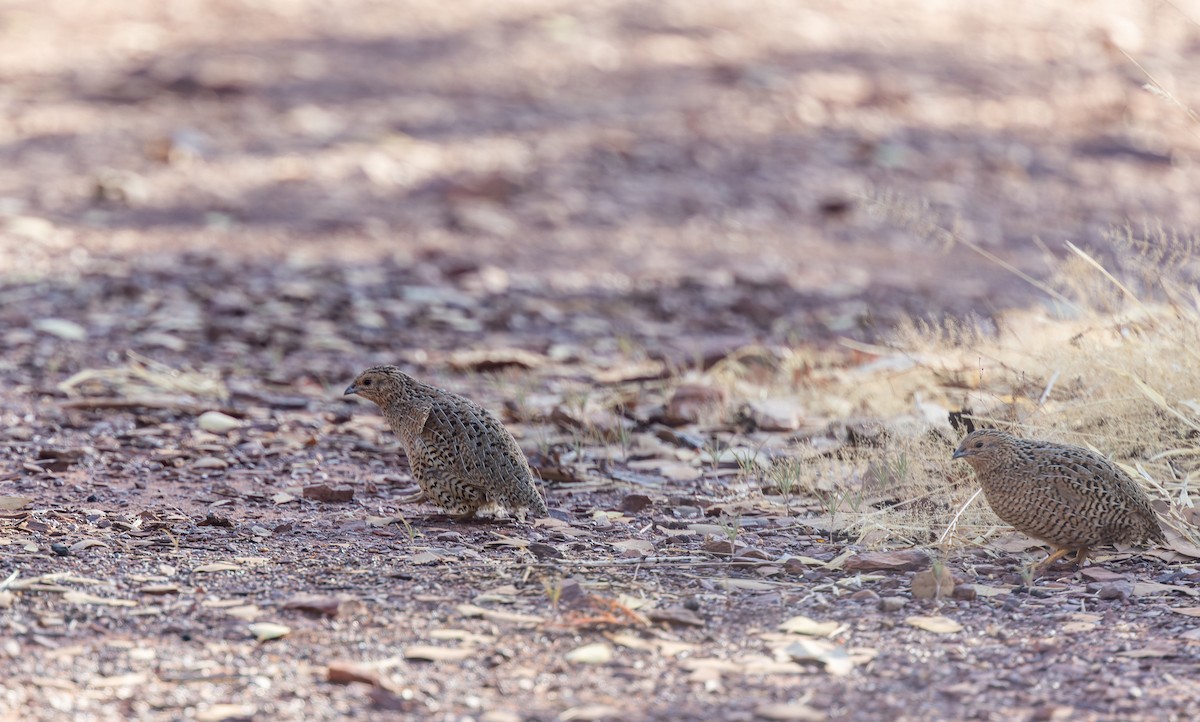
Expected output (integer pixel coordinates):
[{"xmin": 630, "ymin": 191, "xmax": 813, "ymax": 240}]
[{"xmin": 346, "ymin": 366, "xmax": 550, "ymax": 519}]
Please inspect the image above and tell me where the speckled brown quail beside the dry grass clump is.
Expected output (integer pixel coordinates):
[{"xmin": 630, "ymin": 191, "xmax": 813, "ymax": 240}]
[{"xmin": 953, "ymin": 428, "xmax": 1165, "ymax": 566}]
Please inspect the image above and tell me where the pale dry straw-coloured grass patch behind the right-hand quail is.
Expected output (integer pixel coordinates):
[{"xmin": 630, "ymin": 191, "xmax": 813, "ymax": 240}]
[{"xmin": 691, "ymin": 205, "xmax": 1200, "ymax": 552}]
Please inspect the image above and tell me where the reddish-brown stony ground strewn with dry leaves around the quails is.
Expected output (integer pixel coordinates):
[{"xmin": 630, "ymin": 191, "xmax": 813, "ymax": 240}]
[{"xmin": 0, "ymin": 0, "xmax": 1200, "ymax": 722}]
